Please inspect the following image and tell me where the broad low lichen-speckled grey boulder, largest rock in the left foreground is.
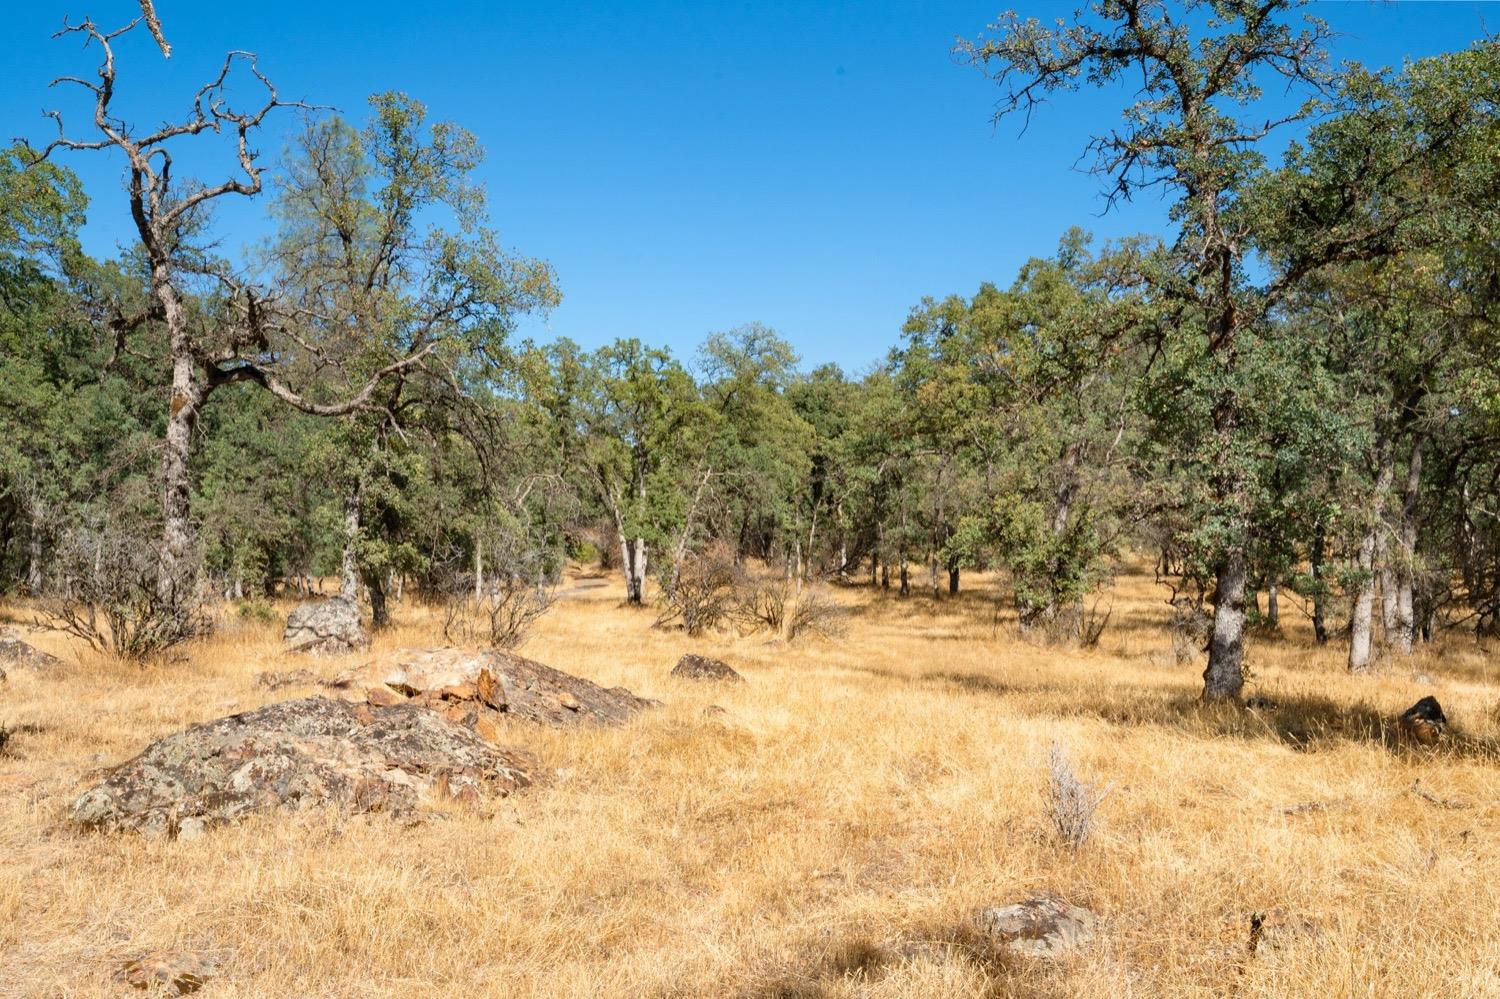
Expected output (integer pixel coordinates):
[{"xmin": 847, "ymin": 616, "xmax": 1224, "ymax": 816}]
[{"xmin": 72, "ymin": 698, "xmax": 539, "ymax": 836}]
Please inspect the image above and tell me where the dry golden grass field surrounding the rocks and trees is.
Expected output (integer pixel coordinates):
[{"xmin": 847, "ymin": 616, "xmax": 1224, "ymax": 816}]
[{"xmin": 0, "ymin": 564, "xmax": 1500, "ymax": 998}]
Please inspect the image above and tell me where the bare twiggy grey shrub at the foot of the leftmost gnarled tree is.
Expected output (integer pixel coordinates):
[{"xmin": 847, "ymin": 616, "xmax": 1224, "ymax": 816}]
[{"xmin": 45, "ymin": 530, "xmax": 209, "ymax": 662}]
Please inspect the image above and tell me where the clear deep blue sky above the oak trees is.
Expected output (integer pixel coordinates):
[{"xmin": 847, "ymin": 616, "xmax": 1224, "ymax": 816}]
[{"xmin": 0, "ymin": 0, "xmax": 1500, "ymax": 369}]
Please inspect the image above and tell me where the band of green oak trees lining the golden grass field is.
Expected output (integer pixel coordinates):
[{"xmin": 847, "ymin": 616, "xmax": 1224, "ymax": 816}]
[{"xmin": 0, "ymin": 0, "xmax": 1500, "ymax": 699}]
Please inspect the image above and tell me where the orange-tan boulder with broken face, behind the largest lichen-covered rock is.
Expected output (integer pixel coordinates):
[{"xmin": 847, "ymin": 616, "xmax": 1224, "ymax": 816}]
[{"xmin": 332, "ymin": 648, "xmax": 656, "ymax": 726}]
